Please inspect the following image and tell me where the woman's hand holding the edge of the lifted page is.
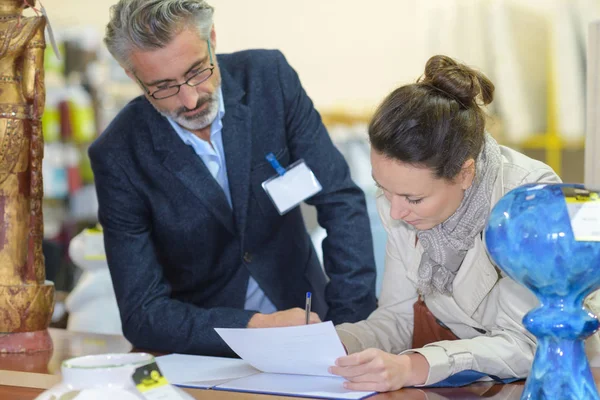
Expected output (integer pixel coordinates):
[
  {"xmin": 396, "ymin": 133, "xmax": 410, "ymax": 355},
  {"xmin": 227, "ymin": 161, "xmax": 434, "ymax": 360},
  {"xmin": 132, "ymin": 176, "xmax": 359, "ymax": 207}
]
[{"xmin": 329, "ymin": 349, "xmax": 429, "ymax": 392}]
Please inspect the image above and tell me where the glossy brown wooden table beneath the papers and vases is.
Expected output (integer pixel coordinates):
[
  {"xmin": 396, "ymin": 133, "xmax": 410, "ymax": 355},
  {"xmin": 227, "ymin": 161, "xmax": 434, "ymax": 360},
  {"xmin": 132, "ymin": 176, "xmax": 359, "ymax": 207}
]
[{"xmin": 0, "ymin": 329, "xmax": 600, "ymax": 400}]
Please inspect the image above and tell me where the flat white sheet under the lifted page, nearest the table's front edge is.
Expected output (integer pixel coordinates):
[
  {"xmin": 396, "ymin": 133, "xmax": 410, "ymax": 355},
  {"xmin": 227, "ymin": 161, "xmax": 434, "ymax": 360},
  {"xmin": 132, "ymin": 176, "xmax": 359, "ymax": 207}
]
[{"xmin": 214, "ymin": 373, "xmax": 374, "ymax": 399}]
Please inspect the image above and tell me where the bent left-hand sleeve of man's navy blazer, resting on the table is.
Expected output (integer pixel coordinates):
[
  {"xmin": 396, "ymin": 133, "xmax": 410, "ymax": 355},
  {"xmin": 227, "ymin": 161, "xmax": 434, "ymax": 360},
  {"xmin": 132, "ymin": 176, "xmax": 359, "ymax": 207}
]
[{"xmin": 89, "ymin": 146, "xmax": 254, "ymax": 356}]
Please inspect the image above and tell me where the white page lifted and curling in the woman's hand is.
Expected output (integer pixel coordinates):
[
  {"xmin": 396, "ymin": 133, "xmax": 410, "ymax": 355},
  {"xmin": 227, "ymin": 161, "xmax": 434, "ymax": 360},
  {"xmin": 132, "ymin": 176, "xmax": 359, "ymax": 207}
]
[{"xmin": 215, "ymin": 321, "xmax": 346, "ymax": 376}]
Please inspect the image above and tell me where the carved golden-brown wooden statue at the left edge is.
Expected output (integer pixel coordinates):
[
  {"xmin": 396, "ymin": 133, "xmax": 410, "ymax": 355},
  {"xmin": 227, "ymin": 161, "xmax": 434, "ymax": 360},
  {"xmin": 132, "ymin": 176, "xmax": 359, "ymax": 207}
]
[{"xmin": 0, "ymin": 0, "xmax": 54, "ymax": 353}]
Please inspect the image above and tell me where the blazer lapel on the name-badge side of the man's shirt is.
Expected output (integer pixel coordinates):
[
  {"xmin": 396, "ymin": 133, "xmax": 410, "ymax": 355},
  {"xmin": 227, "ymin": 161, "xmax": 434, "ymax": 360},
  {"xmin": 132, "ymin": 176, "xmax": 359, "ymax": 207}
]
[{"xmin": 221, "ymin": 68, "xmax": 252, "ymax": 244}]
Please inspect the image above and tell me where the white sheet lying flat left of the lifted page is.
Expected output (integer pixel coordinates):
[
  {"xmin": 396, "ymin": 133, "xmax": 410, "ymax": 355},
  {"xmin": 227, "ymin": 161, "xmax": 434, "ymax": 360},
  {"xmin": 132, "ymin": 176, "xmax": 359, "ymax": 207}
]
[{"xmin": 156, "ymin": 354, "xmax": 260, "ymax": 388}]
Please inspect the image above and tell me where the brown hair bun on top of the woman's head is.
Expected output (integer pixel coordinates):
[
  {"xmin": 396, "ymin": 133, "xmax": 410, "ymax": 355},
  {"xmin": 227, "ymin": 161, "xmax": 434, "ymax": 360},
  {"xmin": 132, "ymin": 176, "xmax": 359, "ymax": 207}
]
[{"xmin": 421, "ymin": 55, "xmax": 494, "ymax": 107}]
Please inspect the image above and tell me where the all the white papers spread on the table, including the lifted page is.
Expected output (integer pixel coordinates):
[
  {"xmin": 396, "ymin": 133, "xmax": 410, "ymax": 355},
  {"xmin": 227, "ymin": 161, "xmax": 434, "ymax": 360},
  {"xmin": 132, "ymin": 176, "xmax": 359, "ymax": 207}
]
[{"xmin": 156, "ymin": 322, "xmax": 375, "ymax": 399}]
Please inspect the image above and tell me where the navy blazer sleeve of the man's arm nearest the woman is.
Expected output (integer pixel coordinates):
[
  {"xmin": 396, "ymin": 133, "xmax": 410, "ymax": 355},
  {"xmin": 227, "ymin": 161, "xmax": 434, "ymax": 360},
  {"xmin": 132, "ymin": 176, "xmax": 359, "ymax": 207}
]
[{"xmin": 277, "ymin": 53, "xmax": 377, "ymax": 324}]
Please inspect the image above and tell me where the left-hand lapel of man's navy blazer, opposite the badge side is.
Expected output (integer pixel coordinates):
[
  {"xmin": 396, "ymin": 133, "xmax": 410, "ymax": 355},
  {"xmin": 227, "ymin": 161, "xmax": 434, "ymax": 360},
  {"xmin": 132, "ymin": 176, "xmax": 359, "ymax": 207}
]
[{"xmin": 149, "ymin": 102, "xmax": 236, "ymax": 234}]
